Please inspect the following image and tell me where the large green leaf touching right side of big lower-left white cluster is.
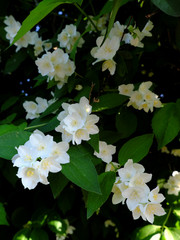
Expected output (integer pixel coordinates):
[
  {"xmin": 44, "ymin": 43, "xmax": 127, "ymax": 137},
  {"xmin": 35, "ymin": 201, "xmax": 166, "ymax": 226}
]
[{"xmin": 62, "ymin": 146, "xmax": 101, "ymax": 194}]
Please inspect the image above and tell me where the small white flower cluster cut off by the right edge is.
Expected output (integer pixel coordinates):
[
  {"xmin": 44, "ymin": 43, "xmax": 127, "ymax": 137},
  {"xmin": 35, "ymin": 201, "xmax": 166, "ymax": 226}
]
[{"xmin": 164, "ymin": 171, "xmax": 180, "ymax": 196}]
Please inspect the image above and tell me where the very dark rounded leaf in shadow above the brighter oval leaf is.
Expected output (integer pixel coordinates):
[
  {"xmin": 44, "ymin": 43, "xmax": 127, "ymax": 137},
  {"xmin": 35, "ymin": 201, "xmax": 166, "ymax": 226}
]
[{"xmin": 116, "ymin": 109, "xmax": 137, "ymax": 138}]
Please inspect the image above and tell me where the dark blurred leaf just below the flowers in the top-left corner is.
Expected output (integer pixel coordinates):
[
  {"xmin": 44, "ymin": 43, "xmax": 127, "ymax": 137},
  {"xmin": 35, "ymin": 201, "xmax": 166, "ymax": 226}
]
[{"xmin": 4, "ymin": 49, "xmax": 28, "ymax": 73}]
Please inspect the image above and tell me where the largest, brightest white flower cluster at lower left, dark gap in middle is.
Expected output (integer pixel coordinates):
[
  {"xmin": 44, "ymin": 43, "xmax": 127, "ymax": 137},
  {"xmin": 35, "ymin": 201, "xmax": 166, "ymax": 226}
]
[{"xmin": 12, "ymin": 130, "xmax": 70, "ymax": 189}]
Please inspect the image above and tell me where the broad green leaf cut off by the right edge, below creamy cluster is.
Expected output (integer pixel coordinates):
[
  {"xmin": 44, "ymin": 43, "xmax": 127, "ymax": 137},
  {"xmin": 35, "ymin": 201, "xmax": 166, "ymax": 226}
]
[{"xmin": 152, "ymin": 103, "xmax": 180, "ymax": 149}]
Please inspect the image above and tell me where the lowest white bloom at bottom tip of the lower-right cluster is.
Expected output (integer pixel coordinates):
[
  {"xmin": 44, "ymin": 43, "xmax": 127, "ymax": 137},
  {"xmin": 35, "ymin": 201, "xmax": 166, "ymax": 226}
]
[{"xmin": 143, "ymin": 203, "xmax": 166, "ymax": 223}]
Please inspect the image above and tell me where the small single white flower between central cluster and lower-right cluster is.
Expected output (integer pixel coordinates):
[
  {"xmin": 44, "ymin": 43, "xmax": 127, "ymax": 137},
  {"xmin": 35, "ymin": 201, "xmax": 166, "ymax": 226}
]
[{"xmin": 94, "ymin": 141, "xmax": 116, "ymax": 163}]
